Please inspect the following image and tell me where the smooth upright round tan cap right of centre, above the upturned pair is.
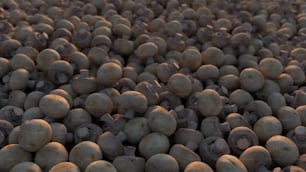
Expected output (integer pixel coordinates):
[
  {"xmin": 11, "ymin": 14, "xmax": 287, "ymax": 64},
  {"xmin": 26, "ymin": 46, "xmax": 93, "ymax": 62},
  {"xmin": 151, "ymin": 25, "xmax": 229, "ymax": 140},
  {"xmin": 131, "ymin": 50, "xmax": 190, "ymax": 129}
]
[{"xmin": 198, "ymin": 89, "xmax": 223, "ymax": 117}]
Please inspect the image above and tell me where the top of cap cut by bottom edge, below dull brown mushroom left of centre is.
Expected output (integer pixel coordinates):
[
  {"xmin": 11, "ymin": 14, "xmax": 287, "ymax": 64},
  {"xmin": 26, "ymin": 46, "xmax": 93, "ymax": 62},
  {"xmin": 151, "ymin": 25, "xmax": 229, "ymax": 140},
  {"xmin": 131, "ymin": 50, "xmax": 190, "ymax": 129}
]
[{"xmin": 84, "ymin": 160, "xmax": 117, "ymax": 172}]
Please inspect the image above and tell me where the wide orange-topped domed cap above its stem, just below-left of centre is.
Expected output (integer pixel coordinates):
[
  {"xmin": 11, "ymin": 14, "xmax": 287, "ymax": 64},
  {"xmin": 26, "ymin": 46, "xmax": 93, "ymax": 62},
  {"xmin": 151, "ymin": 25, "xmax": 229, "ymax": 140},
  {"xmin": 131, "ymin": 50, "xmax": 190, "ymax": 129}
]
[{"xmin": 118, "ymin": 91, "xmax": 148, "ymax": 113}]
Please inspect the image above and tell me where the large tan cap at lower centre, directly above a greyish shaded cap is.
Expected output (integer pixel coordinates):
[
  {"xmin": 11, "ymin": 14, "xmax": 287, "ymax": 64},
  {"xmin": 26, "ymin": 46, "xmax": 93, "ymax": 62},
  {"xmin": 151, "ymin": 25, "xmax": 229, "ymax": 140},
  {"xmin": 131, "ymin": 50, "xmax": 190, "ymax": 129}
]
[{"xmin": 148, "ymin": 106, "xmax": 177, "ymax": 136}]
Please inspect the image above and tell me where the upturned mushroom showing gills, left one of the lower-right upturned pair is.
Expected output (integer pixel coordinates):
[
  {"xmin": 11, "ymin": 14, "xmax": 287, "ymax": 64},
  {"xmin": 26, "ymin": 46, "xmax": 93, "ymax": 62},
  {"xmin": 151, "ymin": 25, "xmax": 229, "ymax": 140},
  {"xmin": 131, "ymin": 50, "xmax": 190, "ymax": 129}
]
[{"xmin": 199, "ymin": 136, "xmax": 231, "ymax": 167}]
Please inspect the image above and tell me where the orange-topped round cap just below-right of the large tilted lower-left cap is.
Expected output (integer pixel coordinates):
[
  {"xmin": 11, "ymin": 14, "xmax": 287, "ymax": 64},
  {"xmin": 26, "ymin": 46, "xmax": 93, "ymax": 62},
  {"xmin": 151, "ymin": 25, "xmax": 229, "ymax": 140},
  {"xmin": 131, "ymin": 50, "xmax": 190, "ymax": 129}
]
[{"xmin": 34, "ymin": 142, "xmax": 68, "ymax": 171}]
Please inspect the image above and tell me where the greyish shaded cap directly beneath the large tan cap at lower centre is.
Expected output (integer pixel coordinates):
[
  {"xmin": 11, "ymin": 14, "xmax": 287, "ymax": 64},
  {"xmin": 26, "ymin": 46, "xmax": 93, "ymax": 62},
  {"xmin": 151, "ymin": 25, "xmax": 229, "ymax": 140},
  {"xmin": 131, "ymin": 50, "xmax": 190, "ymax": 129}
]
[{"xmin": 138, "ymin": 132, "xmax": 170, "ymax": 159}]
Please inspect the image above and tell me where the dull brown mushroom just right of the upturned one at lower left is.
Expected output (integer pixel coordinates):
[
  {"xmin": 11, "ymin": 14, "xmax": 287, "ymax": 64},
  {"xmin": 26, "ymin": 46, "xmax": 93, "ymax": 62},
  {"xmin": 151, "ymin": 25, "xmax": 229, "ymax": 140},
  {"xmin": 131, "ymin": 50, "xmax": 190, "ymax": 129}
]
[{"xmin": 97, "ymin": 131, "xmax": 124, "ymax": 161}]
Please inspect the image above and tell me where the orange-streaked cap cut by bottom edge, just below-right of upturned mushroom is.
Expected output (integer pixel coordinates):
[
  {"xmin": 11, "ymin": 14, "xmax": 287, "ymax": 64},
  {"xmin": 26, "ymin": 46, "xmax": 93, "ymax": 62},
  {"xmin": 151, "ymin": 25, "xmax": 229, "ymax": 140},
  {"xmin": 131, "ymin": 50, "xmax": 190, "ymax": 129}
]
[{"xmin": 216, "ymin": 155, "xmax": 248, "ymax": 172}]
